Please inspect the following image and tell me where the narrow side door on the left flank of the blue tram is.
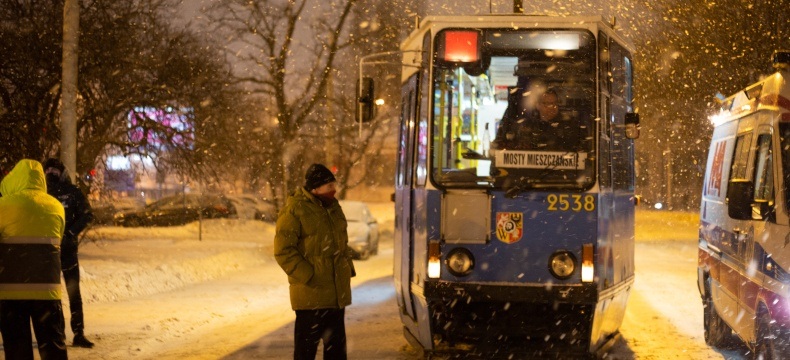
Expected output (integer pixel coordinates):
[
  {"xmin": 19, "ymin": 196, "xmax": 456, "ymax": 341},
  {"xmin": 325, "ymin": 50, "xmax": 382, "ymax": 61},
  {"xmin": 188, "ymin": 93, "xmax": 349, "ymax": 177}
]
[{"xmin": 394, "ymin": 74, "xmax": 418, "ymax": 320}]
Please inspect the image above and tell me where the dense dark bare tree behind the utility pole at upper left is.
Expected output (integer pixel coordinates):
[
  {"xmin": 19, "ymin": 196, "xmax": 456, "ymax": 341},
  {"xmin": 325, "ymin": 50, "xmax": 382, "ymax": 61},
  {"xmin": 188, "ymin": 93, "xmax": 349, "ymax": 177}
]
[{"xmin": 0, "ymin": 0, "xmax": 243, "ymax": 191}]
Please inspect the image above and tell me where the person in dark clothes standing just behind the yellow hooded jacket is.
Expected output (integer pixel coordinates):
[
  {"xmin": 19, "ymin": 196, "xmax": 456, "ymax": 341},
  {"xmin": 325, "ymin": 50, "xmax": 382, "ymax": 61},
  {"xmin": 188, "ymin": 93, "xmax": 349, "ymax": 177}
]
[{"xmin": 44, "ymin": 158, "xmax": 93, "ymax": 348}]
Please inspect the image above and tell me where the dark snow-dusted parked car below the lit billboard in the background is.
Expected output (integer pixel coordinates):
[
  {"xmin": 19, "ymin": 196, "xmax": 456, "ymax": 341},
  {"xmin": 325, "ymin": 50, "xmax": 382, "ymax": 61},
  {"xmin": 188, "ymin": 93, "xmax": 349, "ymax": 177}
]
[{"xmin": 113, "ymin": 194, "xmax": 237, "ymax": 227}]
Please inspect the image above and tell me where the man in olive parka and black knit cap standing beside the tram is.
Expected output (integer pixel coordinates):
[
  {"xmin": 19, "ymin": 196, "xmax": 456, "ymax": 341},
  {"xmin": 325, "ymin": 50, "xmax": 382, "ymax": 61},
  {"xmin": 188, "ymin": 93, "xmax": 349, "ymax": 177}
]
[{"xmin": 274, "ymin": 164, "xmax": 355, "ymax": 360}]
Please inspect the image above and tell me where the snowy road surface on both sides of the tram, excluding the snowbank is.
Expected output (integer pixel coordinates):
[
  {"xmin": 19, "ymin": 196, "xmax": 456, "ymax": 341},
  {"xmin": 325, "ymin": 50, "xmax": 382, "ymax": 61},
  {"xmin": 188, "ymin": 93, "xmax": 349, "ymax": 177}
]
[{"xmin": 0, "ymin": 210, "xmax": 760, "ymax": 360}]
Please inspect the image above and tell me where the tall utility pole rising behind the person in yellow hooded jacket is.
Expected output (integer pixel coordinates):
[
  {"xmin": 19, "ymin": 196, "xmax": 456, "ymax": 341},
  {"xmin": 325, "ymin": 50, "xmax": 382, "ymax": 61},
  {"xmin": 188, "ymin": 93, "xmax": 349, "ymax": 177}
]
[{"xmin": 60, "ymin": 0, "xmax": 80, "ymax": 183}]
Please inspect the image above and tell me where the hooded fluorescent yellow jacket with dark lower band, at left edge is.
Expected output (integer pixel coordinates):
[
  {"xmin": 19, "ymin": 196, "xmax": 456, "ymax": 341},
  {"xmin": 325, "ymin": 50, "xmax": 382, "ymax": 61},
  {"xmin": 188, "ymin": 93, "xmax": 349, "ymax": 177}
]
[{"xmin": 0, "ymin": 159, "xmax": 66, "ymax": 300}]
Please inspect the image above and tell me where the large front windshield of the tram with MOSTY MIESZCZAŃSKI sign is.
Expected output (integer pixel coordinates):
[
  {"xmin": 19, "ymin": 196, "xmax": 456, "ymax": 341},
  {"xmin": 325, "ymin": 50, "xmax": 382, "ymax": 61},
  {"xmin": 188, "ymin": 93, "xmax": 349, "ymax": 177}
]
[{"xmin": 431, "ymin": 29, "xmax": 596, "ymax": 189}]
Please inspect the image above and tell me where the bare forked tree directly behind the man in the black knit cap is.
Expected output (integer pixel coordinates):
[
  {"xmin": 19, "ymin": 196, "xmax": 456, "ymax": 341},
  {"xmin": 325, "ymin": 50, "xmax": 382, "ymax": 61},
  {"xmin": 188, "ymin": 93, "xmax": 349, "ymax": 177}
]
[{"xmin": 207, "ymin": 0, "xmax": 364, "ymax": 205}]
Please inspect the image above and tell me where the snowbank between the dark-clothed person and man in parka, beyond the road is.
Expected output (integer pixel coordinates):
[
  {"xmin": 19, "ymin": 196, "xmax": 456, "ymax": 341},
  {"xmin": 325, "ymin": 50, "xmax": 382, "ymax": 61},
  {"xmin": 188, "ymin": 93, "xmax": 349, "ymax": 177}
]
[{"xmin": 80, "ymin": 219, "xmax": 274, "ymax": 303}]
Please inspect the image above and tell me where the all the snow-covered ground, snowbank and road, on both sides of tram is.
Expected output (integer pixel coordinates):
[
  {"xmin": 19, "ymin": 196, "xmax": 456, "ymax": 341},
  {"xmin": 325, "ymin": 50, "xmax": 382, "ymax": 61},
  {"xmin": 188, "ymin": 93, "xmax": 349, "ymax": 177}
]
[{"xmin": 0, "ymin": 202, "xmax": 746, "ymax": 360}]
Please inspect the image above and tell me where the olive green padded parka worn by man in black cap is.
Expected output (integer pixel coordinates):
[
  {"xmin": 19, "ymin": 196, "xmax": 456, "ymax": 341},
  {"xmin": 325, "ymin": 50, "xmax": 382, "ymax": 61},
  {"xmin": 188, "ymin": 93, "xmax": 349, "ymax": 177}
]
[{"xmin": 274, "ymin": 188, "xmax": 354, "ymax": 310}]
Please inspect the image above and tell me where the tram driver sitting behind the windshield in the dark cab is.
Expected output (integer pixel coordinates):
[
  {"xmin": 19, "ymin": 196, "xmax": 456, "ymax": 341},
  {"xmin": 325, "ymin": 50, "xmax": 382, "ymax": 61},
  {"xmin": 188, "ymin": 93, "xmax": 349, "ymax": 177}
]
[{"xmin": 491, "ymin": 89, "xmax": 583, "ymax": 151}]
